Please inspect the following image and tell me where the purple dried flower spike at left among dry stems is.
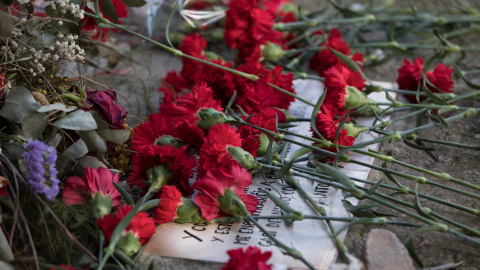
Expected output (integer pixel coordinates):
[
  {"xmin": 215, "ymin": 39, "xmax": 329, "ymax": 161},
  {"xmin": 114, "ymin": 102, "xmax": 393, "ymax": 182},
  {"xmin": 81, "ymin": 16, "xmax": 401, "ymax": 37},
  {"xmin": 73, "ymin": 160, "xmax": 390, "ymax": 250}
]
[{"xmin": 22, "ymin": 139, "xmax": 60, "ymax": 201}]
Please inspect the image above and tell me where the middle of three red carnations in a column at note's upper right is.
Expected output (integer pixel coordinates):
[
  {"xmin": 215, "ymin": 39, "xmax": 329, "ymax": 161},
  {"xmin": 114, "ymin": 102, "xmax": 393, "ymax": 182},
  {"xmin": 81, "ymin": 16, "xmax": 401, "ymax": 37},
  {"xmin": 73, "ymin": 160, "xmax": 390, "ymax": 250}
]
[{"xmin": 324, "ymin": 64, "xmax": 366, "ymax": 109}]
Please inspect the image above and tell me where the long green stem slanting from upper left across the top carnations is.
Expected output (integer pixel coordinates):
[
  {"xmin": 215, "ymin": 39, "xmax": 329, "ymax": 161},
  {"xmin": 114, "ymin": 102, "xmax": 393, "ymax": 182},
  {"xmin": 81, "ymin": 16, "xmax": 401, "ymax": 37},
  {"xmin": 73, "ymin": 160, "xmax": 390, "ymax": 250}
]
[{"xmin": 85, "ymin": 11, "xmax": 315, "ymax": 107}]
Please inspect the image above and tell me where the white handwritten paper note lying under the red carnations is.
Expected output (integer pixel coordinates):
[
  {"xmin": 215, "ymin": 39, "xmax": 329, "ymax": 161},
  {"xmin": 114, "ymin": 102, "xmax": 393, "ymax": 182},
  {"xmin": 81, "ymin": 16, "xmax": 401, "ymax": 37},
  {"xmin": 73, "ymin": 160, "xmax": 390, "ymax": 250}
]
[{"xmin": 144, "ymin": 80, "xmax": 393, "ymax": 270}]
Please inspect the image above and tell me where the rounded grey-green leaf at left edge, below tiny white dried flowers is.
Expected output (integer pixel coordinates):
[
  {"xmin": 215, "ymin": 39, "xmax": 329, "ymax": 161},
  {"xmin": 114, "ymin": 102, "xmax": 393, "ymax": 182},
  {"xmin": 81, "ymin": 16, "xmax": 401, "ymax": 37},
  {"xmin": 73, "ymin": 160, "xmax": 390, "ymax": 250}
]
[{"xmin": 0, "ymin": 86, "xmax": 41, "ymax": 123}]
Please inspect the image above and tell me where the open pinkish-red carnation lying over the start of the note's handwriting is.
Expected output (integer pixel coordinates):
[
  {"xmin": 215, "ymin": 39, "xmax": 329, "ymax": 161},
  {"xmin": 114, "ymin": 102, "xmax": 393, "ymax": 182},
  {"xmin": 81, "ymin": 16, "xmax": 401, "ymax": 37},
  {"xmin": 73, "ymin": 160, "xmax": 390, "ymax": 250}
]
[{"xmin": 193, "ymin": 164, "xmax": 258, "ymax": 222}]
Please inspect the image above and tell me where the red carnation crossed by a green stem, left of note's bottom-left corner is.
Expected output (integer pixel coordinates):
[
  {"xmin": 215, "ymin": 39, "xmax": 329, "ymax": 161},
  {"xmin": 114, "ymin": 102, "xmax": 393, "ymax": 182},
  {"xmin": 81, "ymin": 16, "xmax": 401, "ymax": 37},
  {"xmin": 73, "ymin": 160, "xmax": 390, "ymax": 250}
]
[{"xmin": 97, "ymin": 205, "xmax": 156, "ymax": 245}]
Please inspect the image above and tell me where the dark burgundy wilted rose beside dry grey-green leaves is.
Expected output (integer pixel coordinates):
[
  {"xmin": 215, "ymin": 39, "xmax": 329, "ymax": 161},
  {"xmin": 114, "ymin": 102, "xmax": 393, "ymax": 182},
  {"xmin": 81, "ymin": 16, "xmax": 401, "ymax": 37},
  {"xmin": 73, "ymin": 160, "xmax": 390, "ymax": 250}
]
[{"xmin": 84, "ymin": 89, "xmax": 128, "ymax": 129}]
